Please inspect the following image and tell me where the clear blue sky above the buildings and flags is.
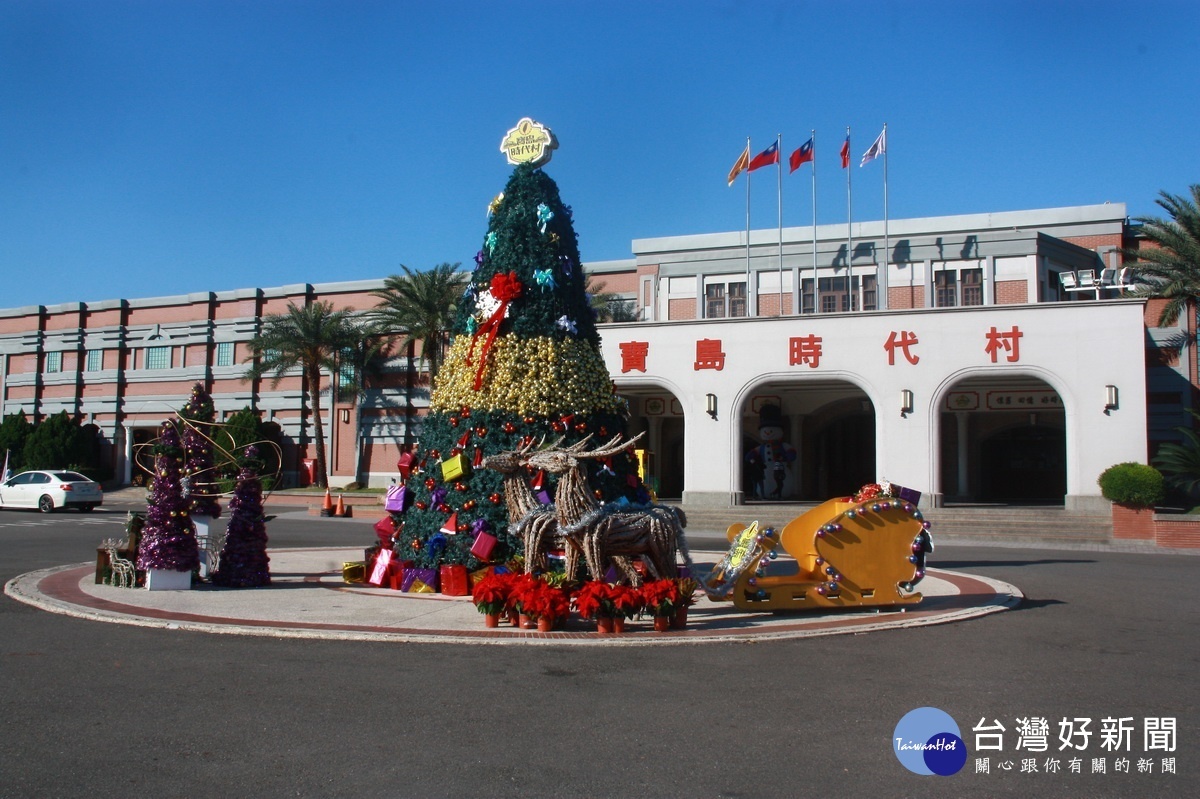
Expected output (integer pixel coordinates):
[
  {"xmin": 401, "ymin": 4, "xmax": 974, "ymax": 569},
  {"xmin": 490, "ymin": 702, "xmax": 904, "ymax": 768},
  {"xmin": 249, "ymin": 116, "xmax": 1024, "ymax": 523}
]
[{"xmin": 0, "ymin": 0, "xmax": 1200, "ymax": 308}]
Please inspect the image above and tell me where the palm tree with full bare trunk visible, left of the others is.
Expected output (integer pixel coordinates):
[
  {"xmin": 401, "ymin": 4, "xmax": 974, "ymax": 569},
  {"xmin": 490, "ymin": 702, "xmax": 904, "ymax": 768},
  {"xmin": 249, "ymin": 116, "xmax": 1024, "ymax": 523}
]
[{"xmin": 246, "ymin": 302, "xmax": 364, "ymax": 488}]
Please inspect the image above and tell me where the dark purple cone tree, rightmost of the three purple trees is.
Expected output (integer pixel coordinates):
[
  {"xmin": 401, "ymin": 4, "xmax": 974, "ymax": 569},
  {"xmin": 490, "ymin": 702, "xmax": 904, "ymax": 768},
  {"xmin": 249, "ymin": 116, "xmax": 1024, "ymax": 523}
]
[{"xmin": 212, "ymin": 446, "xmax": 271, "ymax": 588}]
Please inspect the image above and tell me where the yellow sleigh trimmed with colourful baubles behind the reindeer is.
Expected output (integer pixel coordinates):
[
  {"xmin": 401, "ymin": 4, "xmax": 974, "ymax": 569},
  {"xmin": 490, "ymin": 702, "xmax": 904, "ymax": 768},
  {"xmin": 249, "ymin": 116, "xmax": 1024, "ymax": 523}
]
[{"xmin": 703, "ymin": 487, "xmax": 934, "ymax": 611}]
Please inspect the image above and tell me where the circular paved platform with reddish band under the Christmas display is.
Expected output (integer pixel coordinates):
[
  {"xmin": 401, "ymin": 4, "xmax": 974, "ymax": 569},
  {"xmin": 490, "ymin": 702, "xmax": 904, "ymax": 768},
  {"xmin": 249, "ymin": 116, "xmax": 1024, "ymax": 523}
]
[{"xmin": 5, "ymin": 548, "xmax": 1022, "ymax": 647}]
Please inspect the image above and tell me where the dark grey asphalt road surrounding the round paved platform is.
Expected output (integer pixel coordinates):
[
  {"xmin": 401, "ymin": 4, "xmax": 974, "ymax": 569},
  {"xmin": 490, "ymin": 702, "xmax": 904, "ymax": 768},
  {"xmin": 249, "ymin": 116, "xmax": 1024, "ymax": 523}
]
[{"xmin": 0, "ymin": 507, "xmax": 1200, "ymax": 799}]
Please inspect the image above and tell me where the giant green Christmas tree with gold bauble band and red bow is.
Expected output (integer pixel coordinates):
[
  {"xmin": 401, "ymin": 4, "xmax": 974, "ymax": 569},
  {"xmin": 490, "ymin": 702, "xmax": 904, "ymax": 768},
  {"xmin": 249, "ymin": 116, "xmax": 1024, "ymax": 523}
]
[{"xmin": 396, "ymin": 138, "xmax": 648, "ymax": 569}]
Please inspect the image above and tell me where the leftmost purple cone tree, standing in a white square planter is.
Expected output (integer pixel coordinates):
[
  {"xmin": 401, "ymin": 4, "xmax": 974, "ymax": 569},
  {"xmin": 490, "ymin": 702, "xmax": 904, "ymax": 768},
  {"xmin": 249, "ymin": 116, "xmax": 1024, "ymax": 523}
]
[{"xmin": 137, "ymin": 421, "xmax": 200, "ymax": 571}]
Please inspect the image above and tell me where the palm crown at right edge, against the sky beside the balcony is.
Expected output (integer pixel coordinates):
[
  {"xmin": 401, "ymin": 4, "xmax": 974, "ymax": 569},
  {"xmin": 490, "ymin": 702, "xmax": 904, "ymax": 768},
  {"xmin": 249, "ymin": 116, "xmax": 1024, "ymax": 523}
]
[{"xmin": 1124, "ymin": 184, "xmax": 1200, "ymax": 326}]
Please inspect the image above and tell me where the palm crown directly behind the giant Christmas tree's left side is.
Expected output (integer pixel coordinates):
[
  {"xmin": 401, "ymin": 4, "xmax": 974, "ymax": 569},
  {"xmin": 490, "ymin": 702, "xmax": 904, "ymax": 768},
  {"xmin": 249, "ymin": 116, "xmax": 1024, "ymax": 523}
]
[{"xmin": 371, "ymin": 264, "xmax": 467, "ymax": 380}]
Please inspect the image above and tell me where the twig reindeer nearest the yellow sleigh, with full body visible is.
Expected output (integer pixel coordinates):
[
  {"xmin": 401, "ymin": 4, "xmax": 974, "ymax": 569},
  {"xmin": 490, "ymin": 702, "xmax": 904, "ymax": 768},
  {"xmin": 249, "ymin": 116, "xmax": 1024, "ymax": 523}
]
[{"xmin": 524, "ymin": 433, "xmax": 691, "ymax": 584}]
